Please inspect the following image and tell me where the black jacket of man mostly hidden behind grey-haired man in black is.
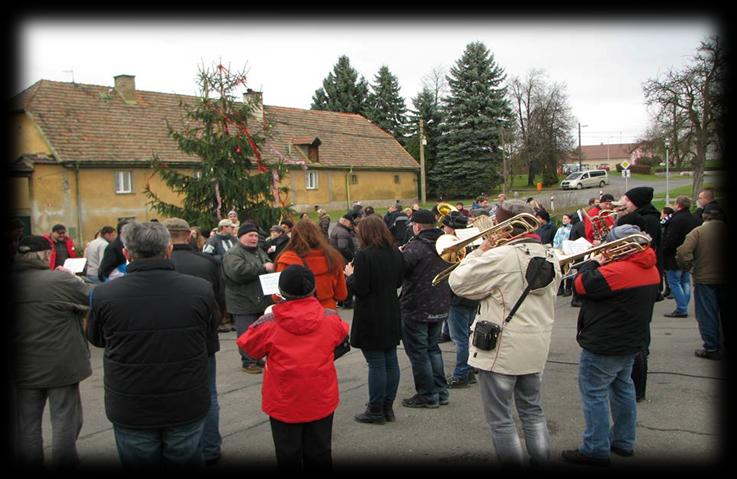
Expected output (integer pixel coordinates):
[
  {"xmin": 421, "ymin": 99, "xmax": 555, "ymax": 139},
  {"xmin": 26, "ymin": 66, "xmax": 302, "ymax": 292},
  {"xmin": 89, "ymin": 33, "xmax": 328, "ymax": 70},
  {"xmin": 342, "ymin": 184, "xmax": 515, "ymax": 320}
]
[{"xmin": 171, "ymin": 244, "xmax": 225, "ymax": 354}]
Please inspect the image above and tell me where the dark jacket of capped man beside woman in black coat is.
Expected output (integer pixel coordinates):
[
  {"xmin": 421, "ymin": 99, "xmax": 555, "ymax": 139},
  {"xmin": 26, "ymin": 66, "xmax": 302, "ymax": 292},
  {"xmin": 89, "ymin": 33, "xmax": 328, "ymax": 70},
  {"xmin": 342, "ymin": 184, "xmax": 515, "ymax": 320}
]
[{"xmin": 399, "ymin": 228, "xmax": 450, "ymax": 323}]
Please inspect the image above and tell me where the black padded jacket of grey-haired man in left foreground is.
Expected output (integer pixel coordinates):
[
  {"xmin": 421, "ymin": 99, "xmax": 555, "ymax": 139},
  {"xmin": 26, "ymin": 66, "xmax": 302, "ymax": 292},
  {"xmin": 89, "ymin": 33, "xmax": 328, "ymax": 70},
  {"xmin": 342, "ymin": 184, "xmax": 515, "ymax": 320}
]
[{"xmin": 87, "ymin": 258, "xmax": 220, "ymax": 429}]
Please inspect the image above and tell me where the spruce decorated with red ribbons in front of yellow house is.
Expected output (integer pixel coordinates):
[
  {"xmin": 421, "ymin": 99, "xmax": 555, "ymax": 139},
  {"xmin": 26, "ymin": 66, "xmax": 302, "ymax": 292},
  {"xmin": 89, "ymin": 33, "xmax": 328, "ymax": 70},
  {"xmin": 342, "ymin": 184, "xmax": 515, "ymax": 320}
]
[{"xmin": 144, "ymin": 64, "xmax": 290, "ymax": 231}]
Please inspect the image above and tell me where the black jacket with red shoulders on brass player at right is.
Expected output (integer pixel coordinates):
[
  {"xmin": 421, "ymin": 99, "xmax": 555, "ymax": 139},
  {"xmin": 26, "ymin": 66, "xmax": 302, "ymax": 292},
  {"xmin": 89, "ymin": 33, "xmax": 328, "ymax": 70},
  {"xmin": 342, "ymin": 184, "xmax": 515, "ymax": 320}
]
[{"xmin": 573, "ymin": 248, "xmax": 660, "ymax": 356}]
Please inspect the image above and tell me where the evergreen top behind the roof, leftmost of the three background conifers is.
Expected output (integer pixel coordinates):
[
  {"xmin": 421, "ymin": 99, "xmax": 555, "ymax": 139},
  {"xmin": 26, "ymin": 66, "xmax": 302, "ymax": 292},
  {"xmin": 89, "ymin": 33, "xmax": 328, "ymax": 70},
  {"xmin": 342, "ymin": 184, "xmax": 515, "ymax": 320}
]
[{"xmin": 311, "ymin": 55, "xmax": 368, "ymax": 115}]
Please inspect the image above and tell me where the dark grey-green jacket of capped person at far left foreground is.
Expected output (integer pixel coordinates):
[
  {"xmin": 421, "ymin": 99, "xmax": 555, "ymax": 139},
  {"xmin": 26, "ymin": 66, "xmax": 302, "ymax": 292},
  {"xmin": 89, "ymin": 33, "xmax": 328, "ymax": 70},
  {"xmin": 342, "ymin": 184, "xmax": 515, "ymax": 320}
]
[{"xmin": 11, "ymin": 260, "xmax": 92, "ymax": 388}]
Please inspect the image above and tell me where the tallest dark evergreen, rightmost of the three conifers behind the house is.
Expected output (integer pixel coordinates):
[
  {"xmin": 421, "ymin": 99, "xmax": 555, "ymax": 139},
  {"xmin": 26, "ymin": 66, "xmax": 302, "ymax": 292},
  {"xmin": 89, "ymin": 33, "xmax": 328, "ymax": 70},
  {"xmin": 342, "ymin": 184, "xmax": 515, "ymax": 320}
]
[{"xmin": 428, "ymin": 42, "xmax": 511, "ymax": 197}]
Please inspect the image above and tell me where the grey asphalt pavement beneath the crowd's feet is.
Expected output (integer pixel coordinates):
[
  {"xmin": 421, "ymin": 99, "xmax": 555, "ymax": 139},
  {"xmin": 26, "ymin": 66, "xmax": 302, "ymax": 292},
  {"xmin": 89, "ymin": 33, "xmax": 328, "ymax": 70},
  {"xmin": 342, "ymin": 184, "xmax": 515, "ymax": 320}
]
[{"xmin": 44, "ymin": 288, "xmax": 731, "ymax": 473}]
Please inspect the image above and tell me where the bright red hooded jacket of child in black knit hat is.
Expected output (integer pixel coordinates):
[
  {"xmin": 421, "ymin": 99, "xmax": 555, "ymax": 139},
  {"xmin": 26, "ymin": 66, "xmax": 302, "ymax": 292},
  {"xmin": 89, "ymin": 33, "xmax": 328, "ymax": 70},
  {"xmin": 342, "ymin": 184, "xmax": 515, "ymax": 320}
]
[{"xmin": 236, "ymin": 297, "xmax": 348, "ymax": 423}]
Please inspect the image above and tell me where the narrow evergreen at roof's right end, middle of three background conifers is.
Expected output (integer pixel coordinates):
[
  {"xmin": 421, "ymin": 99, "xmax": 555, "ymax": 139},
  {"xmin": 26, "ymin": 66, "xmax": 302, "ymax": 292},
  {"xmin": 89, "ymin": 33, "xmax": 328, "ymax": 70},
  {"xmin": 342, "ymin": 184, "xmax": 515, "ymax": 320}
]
[{"xmin": 366, "ymin": 66, "xmax": 407, "ymax": 144}]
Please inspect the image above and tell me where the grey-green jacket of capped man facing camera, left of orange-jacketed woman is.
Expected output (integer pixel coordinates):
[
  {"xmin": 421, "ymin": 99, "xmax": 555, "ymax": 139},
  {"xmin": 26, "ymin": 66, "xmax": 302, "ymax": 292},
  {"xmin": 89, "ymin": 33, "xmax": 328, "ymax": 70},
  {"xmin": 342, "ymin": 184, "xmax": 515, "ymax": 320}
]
[{"xmin": 223, "ymin": 243, "xmax": 273, "ymax": 314}]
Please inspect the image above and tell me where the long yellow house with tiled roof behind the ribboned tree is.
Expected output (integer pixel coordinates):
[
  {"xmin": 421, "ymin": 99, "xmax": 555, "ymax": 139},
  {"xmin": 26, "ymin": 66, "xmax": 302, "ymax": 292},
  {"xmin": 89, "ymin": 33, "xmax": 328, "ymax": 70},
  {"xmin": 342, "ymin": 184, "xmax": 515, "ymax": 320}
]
[{"xmin": 10, "ymin": 75, "xmax": 420, "ymax": 243}]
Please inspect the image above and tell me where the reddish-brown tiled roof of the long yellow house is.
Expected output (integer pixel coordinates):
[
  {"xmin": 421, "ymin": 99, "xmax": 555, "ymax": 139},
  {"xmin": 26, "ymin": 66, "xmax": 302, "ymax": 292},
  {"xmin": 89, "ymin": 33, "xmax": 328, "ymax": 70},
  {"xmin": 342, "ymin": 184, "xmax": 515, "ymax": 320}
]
[{"xmin": 11, "ymin": 80, "xmax": 419, "ymax": 169}]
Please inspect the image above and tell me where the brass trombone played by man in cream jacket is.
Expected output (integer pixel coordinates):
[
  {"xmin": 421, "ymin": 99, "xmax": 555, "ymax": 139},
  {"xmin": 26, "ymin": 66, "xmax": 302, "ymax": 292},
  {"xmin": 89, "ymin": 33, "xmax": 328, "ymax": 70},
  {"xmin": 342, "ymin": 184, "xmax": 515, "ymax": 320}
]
[{"xmin": 432, "ymin": 213, "xmax": 542, "ymax": 286}]
